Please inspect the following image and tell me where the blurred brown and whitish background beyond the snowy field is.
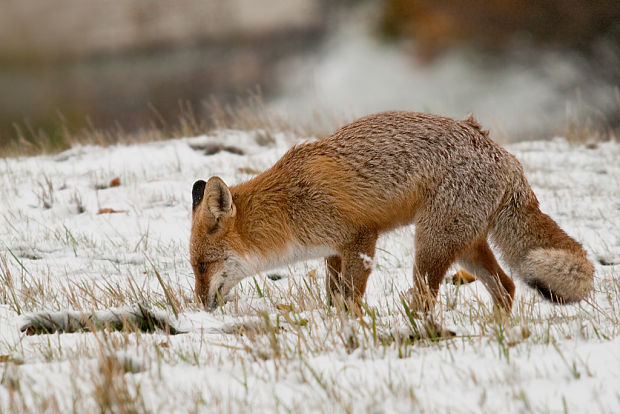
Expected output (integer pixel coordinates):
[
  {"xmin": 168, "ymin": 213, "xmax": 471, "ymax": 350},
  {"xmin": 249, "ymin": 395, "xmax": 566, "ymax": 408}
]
[{"xmin": 0, "ymin": 0, "xmax": 620, "ymax": 151}]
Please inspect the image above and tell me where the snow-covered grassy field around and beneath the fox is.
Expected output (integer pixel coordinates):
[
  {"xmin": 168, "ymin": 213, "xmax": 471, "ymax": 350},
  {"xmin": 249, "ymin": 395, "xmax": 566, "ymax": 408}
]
[{"xmin": 0, "ymin": 131, "xmax": 620, "ymax": 413}]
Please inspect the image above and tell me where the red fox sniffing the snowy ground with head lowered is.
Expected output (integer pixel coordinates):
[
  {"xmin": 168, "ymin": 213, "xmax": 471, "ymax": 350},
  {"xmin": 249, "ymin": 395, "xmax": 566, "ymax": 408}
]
[{"xmin": 190, "ymin": 112, "xmax": 594, "ymax": 312}]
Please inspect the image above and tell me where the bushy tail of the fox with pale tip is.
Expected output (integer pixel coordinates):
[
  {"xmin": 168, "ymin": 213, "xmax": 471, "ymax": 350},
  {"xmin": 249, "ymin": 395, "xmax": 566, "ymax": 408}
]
[{"xmin": 491, "ymin": 176, "xmax": 594, "ymax": 303}]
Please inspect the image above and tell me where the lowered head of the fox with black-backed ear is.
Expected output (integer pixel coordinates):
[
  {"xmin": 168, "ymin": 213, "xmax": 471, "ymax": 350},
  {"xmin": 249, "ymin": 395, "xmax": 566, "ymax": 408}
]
[{"xmin": 189, "ymin": 177, "xmax": 255, "ymax": 310}]
